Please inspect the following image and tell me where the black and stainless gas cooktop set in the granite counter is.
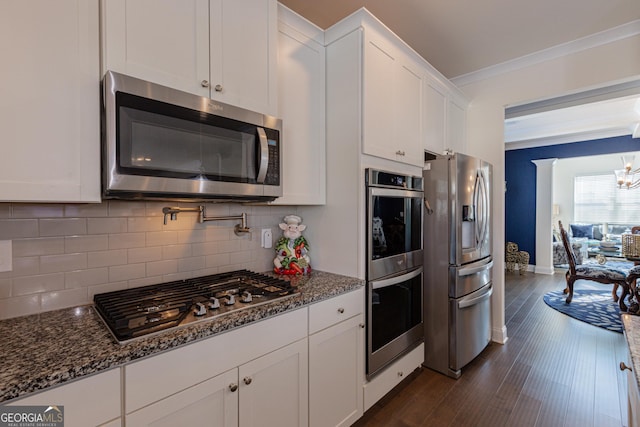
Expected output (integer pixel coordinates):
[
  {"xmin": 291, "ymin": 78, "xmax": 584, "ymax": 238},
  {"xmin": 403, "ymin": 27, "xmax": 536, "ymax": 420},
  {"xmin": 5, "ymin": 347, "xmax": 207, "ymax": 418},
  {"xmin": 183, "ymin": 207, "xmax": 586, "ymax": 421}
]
[{"xmin": 93, "ymin": 270, "xmax": 298, "ymax": 343}]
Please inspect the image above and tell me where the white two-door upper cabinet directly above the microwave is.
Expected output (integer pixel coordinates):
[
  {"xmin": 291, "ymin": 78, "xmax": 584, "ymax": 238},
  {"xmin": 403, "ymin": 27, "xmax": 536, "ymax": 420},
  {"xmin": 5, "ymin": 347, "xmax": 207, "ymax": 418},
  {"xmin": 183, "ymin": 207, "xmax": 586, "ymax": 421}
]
[{"xmin": 102, "ymin": 0, "xmax": 277, "ymax": 116}]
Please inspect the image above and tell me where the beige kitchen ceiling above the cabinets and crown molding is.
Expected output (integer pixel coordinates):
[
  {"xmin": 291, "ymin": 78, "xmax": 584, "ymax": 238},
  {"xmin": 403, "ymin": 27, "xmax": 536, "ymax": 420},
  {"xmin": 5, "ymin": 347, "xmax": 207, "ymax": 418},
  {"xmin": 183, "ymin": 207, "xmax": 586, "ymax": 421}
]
[{"xmin": 279, "ymin": 0, "xmax": 640, "ymax": 79}]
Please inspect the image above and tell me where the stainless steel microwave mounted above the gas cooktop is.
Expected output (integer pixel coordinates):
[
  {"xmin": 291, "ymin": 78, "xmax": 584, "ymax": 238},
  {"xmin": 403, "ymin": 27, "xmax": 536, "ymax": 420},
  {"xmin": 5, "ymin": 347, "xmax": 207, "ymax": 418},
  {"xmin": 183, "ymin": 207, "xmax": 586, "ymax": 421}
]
[{"xmin": 102, "ymin": 71, "xmax": 282, "ymax": 201}]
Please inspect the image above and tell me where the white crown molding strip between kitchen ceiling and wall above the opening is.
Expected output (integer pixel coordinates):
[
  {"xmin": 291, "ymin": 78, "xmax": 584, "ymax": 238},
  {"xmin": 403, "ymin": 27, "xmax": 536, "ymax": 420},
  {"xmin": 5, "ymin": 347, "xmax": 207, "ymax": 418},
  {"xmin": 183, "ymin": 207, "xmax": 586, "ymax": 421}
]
[{"xmin": 451, "ymin": 19, "xmax": 640, "ymax": 87}]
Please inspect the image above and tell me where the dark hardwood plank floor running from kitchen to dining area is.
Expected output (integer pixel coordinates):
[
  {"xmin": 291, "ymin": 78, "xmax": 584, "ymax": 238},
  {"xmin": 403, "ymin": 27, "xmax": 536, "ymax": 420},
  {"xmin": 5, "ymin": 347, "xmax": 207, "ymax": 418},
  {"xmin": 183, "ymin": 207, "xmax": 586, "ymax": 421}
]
[{"xmin": 356, "ymin": 272, "xmax": 627, "ymax": 427}]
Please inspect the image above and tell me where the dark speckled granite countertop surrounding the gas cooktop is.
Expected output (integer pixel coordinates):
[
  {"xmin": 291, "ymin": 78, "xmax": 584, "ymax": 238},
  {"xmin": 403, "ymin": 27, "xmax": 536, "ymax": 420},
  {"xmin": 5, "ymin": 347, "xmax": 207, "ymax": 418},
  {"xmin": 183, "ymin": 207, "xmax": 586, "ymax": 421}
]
[{"xmin": 0, "ymin": 271, "xmax": 364, "ymax": 402}]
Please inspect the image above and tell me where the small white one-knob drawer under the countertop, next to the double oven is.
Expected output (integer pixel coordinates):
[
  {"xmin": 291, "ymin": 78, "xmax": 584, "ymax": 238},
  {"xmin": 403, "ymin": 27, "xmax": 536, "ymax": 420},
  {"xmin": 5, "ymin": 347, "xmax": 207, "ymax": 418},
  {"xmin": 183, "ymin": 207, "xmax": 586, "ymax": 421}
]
[{"xmin": 309, "ymin": 288, "xmax": 364, "ymax": 334}]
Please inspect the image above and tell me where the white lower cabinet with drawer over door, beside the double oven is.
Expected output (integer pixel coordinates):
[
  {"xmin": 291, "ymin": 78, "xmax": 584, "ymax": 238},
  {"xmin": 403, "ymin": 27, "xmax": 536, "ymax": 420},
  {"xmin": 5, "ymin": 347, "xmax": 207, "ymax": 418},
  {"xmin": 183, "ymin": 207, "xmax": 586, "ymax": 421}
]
[{"xmin": 309, "ymin": 289, "xmax": 364, "ymax": 427}]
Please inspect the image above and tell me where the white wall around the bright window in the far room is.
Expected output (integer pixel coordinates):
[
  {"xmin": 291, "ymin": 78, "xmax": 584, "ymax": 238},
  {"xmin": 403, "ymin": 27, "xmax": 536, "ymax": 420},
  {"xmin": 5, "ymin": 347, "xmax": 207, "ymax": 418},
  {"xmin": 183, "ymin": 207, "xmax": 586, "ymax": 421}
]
[{"xmin": 553, "ymin": 150, "xmax": 640, "ymax": 227}]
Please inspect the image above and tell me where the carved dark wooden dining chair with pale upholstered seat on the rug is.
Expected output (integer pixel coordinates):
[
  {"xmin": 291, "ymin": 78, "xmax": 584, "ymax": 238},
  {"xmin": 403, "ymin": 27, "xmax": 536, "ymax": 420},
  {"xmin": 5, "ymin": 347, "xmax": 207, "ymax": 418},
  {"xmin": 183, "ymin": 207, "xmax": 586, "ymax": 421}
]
[{"xmin": 558, "ymin": 221, "xmax": 640, "ymax": 311}]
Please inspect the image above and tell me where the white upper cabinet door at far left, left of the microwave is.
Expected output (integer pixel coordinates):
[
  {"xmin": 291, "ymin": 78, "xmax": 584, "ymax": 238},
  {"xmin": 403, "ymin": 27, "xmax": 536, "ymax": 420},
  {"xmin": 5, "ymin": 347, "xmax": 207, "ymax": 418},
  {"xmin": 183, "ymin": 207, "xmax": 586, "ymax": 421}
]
[{"xmin": 0, "ymin": 0, "xmax": 100, "ymax": 202}]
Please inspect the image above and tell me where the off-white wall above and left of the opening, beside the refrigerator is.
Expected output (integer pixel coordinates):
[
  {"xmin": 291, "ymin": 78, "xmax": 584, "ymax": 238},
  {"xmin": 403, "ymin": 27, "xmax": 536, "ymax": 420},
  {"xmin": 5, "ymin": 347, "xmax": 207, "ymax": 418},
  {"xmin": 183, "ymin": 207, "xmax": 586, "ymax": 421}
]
[{"xmin": 457, "ymin": 35, "xmax": 640, "ymax": 342}]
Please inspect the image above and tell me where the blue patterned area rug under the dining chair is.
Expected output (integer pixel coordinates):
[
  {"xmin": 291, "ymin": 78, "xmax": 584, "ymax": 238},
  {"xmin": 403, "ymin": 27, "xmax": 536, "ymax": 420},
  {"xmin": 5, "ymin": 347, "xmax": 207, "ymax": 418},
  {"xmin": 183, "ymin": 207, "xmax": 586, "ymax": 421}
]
[{"xmin": 543, "ymin": 289, "xmax": 622, "ymax": 333}]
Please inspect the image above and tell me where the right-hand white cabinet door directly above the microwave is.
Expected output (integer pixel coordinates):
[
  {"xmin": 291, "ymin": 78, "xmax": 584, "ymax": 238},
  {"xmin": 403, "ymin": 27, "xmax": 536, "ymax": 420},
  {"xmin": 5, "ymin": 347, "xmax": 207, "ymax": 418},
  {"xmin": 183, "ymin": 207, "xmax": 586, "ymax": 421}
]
[{"xmin": 210, "ymin": 0, "xmax": 278, "ymax": 116}]
